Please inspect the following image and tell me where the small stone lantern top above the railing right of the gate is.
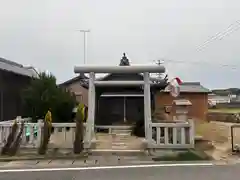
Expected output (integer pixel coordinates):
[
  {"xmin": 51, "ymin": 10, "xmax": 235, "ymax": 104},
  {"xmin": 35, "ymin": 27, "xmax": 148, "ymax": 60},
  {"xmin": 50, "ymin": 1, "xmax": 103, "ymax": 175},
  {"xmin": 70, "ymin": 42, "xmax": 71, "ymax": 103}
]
[{"xmin": 173, "ymin": 99, "xmax": 192, "ymax": 121}]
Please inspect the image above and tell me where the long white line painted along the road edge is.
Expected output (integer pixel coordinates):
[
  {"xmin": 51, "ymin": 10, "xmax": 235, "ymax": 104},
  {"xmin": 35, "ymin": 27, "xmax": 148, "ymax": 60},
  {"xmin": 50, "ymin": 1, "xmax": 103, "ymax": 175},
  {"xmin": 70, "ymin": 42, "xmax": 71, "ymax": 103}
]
[{"xmin": 0, "ymin": 163, "xmax": 214, "ymax": 173}]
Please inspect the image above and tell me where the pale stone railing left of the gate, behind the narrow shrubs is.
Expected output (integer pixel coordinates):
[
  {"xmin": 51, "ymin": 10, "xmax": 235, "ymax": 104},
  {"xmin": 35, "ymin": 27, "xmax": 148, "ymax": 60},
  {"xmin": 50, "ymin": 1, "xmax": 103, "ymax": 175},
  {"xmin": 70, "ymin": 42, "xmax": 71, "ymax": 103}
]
[{"xmin": 0, "ymin": 120, "xmax": 86, "ymax": 148}]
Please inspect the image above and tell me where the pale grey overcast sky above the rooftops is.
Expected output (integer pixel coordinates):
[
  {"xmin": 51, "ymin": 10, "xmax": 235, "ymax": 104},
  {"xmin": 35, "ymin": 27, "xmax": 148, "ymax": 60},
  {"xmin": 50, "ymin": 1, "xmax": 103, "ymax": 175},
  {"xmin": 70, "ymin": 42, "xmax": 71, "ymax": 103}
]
[{"xmin": 0, "ymin": 0, "xmax": 240, "ymax": 89}]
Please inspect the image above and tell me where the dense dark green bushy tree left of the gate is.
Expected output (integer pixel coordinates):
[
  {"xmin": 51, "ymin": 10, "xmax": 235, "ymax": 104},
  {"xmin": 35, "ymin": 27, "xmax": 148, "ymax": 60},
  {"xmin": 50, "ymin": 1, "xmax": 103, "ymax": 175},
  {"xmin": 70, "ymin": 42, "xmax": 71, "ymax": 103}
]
[{"xmin": 22, "ymin": 72, "xmax": 76, "ymax": 122}]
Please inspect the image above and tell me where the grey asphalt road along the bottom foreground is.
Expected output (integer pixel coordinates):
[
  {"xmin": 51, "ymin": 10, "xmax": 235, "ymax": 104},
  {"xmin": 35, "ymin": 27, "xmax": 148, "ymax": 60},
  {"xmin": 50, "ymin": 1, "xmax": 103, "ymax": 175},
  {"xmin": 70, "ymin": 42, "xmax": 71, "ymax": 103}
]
[{"xmin": 0, "ymin": 164, "xmax": 240, "ymax": 180}]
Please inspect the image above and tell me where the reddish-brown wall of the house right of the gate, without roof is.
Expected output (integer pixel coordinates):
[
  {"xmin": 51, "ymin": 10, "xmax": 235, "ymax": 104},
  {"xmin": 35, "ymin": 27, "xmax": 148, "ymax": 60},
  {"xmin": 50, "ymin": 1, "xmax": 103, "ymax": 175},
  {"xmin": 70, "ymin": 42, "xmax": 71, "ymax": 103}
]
[{"xmin": 155, "ymin": 92, "xmax": 208, "ymax": 120}]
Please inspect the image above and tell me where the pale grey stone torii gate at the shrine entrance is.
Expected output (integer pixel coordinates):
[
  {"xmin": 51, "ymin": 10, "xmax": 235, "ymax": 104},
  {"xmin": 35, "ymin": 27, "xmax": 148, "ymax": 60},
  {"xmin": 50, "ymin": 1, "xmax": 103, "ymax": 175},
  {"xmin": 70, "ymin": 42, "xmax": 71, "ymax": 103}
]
[{"xmin": 74, "ymin": 65, "xmax": 165, "ymax": 149}]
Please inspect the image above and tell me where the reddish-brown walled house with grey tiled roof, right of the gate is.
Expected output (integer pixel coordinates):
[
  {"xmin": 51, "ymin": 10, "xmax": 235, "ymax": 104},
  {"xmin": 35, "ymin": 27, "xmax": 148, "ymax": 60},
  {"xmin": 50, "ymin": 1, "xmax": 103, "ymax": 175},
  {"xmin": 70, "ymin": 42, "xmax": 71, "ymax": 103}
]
[{"xmin": 155, "ymin": 82, "xmax": 211, "ymax": 119}]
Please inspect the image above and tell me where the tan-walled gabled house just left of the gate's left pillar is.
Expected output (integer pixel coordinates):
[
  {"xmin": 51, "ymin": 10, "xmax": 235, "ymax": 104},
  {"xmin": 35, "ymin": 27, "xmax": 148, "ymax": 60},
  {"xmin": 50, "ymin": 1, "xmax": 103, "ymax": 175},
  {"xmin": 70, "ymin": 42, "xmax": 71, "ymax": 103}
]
[{"xmin": 59, "ymin": 75, "xmax": 88, "ymax": 106}]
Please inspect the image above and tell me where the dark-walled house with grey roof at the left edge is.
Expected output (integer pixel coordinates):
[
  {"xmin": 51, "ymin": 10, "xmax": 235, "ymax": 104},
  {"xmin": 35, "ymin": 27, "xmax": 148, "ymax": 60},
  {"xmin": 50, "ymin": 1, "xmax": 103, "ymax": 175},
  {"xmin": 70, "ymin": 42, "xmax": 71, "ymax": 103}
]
[{"xmin": 0, "ymin": 58, "xmax": 38, "ymax": 121}]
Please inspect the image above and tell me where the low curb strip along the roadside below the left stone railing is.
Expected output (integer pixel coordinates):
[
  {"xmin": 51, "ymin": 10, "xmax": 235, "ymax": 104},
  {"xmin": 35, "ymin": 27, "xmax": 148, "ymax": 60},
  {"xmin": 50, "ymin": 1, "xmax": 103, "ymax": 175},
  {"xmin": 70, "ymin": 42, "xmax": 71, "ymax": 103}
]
[{"xmin": 0, "ymin": 154, "xmax": 88, "ymax": 162}]
